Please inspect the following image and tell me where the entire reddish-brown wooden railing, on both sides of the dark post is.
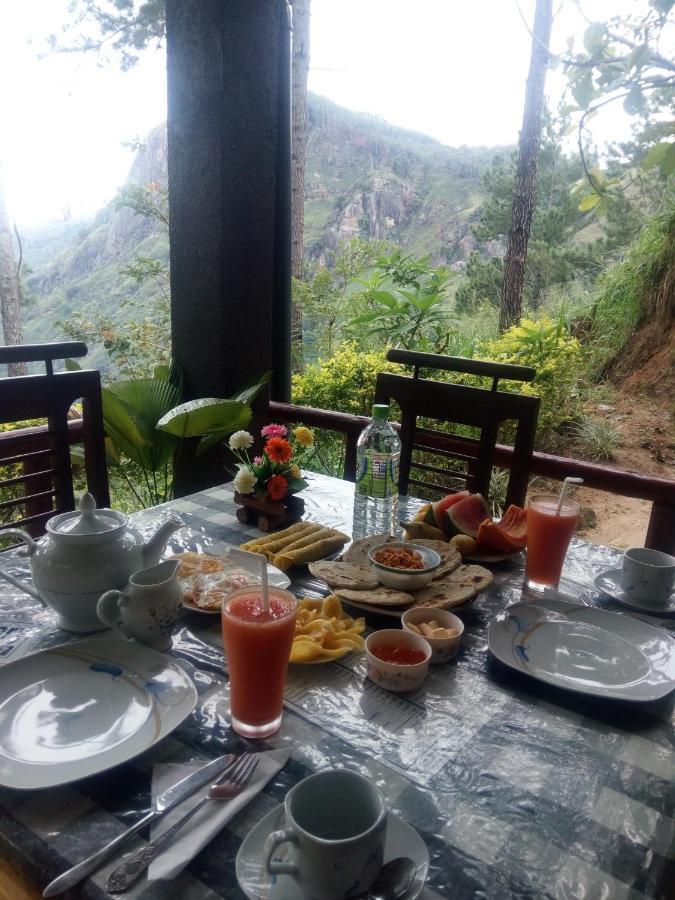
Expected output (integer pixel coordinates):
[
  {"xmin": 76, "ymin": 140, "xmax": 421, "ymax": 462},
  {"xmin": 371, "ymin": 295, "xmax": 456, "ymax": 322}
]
[{"xmin": 5, "ymin": 401, "xmax": 675, "ymax": 553}]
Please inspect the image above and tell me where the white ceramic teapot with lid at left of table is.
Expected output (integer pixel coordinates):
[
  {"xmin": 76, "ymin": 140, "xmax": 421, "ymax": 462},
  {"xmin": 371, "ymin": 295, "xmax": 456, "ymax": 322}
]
[{"xmin": 3, "ymin": 494, "xmax": 183, "ymax": 632}]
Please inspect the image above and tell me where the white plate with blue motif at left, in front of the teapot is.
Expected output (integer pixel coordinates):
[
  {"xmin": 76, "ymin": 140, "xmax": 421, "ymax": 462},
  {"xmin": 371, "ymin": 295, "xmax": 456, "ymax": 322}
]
[{"xmin": 0, "ymin": 635, "xmax": 197, "ymax": 790}]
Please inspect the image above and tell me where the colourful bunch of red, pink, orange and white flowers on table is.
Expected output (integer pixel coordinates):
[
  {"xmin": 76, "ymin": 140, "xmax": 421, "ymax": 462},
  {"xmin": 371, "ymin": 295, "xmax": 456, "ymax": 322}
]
[{"xmin": 229, "ymin": 424, "xmax": 314, "ymax": 502}]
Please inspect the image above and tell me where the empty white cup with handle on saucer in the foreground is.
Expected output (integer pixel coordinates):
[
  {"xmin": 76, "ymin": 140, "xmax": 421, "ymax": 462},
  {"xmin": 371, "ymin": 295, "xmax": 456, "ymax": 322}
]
[{"xmin": 263, "ymin": 769, "xmax": 387, "ymax": 900}]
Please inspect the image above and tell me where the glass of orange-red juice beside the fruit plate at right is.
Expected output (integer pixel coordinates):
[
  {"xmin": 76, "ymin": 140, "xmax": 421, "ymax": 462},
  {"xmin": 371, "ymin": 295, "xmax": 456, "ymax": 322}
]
[{"xmin": 525, "ymin": 494, "xmax": 579, "ymax": 591}]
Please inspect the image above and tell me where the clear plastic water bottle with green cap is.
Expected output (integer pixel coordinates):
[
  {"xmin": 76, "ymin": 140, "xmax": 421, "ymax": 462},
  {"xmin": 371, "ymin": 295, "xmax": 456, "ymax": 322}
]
[{"xmin": 352, "ymin": 403, "xmax": 401, "ymax": 539}]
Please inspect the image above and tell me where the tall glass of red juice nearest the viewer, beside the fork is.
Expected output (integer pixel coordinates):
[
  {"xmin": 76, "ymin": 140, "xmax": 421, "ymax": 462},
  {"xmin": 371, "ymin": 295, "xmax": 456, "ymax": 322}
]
[{"xmin": 222, "ymin": 586, "xmax": 298, "ymax": 738}]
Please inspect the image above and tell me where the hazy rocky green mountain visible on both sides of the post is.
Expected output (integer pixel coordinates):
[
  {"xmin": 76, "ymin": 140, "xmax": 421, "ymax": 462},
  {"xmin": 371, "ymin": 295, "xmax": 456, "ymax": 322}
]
[{"xmin": 24, "ymin": 95, "xmax": 503, "ymax": 352}]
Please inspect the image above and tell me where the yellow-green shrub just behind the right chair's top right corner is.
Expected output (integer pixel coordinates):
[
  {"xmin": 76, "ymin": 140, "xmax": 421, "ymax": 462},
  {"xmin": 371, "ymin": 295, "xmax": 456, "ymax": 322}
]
[{"xmin": 476, "ymin": 316, "xmax": 586, "ymax": 449}]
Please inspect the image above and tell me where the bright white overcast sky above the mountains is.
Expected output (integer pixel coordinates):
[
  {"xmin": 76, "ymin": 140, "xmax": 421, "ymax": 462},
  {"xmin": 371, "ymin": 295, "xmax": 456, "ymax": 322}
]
[{"xmin": 0, "ymin": 0, "xmax": 646, "ymax": 225}]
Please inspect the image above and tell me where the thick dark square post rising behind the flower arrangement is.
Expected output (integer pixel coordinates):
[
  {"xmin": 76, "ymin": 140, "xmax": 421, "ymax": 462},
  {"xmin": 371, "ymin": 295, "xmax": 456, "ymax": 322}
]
[{"xmin": 166, "ymin": 0, "xmax": 290, "ymax": 495}]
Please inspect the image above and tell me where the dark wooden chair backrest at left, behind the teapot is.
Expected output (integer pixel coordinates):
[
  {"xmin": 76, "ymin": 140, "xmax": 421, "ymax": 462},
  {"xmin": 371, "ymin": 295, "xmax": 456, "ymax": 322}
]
[{"xmin": 0, "ymin": 341, "xmax": 110, "ymax": 536}]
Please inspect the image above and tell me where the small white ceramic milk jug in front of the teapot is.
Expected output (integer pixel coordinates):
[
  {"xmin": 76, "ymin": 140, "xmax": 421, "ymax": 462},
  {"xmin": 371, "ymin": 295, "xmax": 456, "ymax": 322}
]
[{"xmin": 96, "ymin": 559, "xmax": 183, "ymax": 650}]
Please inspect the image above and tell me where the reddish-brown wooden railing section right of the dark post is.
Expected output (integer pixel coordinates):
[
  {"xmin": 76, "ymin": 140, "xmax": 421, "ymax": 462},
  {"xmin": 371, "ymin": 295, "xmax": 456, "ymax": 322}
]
[{"xmin": 270, "ymin": 401, "xmax": 675, "ymax": 553}]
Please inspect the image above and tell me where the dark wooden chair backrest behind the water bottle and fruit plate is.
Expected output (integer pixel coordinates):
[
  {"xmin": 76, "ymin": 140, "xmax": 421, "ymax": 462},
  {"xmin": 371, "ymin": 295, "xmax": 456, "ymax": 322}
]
[{"xmin": 375, "ymin": 350, "xmax": 539, "ymax": 505}]
